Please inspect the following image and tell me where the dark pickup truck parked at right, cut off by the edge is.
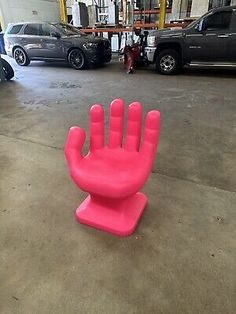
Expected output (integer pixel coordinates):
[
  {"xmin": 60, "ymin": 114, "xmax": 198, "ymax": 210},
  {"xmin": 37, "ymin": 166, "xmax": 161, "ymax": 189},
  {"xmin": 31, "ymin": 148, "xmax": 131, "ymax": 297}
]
[{"xmin": 145, "ymin": 6, "xmax": 236, "ymax": 74}]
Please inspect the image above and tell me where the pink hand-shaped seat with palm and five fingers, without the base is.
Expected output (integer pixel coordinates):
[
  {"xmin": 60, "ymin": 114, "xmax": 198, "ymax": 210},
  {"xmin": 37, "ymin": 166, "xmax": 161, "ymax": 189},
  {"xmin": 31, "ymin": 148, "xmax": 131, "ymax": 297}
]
[{"xmin": 65, "ymin": 99, "xmax": 160, "ymax": 198}]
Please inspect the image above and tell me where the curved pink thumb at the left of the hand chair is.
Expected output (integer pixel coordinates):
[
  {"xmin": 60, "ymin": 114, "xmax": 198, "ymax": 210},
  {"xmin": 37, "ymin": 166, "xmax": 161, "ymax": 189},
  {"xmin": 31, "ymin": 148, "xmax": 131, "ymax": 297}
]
[{"xmin": 65, "ymin": 126, "xmax": 86, "ymax": 170}]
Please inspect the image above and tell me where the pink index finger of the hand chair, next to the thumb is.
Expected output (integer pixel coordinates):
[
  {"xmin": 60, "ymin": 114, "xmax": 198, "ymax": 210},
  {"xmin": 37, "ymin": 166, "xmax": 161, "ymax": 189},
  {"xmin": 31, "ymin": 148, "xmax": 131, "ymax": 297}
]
[{"xmin": 90, "ymin": 105, "xmax": 104, "ymax": 150}]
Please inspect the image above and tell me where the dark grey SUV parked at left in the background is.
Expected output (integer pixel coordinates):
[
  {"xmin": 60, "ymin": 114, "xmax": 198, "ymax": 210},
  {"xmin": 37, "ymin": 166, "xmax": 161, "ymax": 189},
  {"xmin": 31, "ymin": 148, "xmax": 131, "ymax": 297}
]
[{"xmin": 4, "ymin": 22, "xmax": 111, "ymax": 70}]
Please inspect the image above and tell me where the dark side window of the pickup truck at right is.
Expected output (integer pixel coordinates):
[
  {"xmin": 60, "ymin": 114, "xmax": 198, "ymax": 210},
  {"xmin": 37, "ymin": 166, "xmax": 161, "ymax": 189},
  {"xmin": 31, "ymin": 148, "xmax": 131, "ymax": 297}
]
[{"xmin": 203, "ymin": 11, "xmax": 232, "ymax": 30}]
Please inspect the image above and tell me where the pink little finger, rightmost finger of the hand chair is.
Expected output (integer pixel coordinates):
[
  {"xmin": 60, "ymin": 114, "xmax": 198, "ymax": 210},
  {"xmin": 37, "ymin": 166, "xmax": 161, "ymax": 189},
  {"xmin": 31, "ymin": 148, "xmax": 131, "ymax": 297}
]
[{"xmin": 141, "ymin": 110, "xmax": 160, "ymax": 160}]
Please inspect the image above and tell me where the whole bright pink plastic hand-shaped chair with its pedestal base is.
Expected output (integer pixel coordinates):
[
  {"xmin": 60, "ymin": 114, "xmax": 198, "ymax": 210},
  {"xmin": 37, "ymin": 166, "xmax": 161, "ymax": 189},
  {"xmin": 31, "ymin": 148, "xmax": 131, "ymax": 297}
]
[{"xmin": 65, "ymin": 99, "xmax": 160, "ymax": 236}]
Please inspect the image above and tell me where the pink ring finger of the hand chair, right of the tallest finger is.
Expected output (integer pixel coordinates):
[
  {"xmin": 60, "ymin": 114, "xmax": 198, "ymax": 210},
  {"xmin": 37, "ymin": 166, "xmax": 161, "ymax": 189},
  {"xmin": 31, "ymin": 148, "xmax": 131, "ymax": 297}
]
[{"xmin": 125, "ymin": 102, "xmax": 142, "ymax": 151}]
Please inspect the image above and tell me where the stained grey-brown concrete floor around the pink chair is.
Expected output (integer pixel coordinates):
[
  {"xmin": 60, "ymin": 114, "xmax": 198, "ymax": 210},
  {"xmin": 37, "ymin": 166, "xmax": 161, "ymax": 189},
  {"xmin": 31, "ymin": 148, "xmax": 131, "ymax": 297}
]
[{"xmin": 0, "ymin": 57, "xmax": 236, "ymax": 314}]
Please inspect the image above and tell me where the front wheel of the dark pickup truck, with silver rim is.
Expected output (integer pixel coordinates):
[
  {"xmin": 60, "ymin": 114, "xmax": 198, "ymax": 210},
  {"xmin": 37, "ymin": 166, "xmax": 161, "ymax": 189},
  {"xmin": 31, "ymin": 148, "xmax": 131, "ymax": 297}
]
[{"xmin": 156, "ymin": 49, "xmax": 181, "ymax": 75}]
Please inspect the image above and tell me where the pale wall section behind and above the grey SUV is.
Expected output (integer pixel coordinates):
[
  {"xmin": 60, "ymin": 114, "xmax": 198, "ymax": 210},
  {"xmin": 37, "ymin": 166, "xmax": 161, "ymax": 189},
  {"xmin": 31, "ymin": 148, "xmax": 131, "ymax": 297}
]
[{"xmin": 0, "ymin": 0, "xmax": 60, "ymax": 29}]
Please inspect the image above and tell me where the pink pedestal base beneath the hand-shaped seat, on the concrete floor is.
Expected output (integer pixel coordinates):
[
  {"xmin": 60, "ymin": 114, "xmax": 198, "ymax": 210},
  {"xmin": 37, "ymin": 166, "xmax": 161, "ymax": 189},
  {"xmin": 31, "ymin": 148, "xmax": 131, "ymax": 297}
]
[{"xmin": 75, "ymin": 192, "xmax": 147, "ymax": 236}]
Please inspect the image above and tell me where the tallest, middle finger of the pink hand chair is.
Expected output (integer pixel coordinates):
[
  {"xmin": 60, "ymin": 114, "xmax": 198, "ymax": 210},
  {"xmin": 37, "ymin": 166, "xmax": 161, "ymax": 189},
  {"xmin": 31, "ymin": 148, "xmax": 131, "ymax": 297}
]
[{"xmin": 108, "ymin": 99, "xmax": 124, "ymax": 148}]
